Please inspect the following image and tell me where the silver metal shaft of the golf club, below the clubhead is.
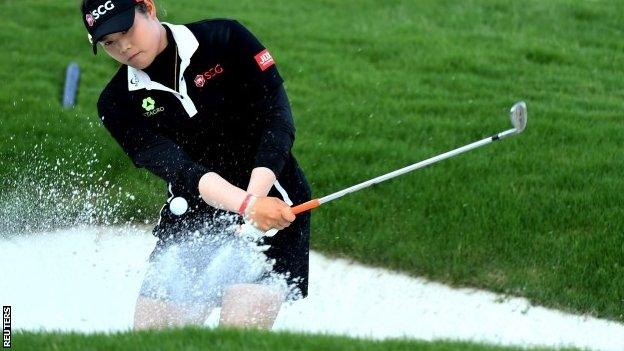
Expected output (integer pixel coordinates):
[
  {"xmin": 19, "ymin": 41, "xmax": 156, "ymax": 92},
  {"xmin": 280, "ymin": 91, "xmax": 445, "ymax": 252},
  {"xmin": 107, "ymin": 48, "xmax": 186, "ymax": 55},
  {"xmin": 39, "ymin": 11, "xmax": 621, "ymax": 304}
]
[{"xmin": 318, "ymin": 129, "xmax": 517, "ymax": 206}]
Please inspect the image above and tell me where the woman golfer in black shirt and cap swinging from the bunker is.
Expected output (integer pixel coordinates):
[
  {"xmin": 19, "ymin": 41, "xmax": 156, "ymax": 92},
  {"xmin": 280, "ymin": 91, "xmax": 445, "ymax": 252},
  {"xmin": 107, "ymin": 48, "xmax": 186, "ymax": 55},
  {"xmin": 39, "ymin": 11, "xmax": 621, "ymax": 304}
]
[{"xmin": 81, "ymin": 0, "xmax": 310, "ymax": 328}]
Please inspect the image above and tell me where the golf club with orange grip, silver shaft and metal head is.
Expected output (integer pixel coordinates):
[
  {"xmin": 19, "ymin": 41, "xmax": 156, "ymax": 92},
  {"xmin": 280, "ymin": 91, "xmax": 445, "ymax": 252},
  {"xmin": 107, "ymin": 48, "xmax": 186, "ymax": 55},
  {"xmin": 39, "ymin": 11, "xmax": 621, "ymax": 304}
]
[{"xmin": 292, "ymin": 101, "xmax": 528, "ymax": 214}]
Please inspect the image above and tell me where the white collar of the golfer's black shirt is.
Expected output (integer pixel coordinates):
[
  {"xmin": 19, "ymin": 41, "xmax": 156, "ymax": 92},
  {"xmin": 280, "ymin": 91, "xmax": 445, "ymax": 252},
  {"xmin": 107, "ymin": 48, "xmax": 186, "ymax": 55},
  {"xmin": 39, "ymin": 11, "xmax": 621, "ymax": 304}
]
[{"xmin": 128, "ymin": 22, "xmax": 199, "ymax": 91}]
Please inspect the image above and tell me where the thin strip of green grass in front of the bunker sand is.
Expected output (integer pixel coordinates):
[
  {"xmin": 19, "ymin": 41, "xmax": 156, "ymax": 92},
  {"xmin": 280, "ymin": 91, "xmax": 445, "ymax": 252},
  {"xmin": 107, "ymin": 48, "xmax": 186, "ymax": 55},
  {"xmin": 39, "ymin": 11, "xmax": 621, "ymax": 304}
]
[{"xmin": 13, "ymin": 328, "xmax": 584, "ymax": 351}]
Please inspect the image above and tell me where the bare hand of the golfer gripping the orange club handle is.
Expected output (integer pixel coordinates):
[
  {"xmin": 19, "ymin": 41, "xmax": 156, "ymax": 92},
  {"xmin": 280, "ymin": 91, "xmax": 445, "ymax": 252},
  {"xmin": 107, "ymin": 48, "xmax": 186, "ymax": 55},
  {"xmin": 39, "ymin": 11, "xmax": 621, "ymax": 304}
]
[{"xmin": 245, "ymin": 197, "xmax": 296, "ymax": 232}]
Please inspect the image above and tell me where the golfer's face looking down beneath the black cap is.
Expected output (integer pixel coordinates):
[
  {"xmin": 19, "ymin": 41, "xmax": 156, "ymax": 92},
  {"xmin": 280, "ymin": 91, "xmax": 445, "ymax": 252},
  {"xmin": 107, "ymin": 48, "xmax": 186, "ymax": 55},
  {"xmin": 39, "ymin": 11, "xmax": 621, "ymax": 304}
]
[{"xmin": 100, "ymin": 1, "xmax": 167, "ymax": 69}]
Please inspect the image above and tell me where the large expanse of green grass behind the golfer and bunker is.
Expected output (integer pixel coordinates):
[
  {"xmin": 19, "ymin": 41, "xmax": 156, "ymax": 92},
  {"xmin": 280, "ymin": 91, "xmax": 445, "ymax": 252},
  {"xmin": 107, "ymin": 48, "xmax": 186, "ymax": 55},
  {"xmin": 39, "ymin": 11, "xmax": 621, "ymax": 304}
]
[{"xmin": 0, "ymin": 0, "xmax": 624, "ymax": 328}]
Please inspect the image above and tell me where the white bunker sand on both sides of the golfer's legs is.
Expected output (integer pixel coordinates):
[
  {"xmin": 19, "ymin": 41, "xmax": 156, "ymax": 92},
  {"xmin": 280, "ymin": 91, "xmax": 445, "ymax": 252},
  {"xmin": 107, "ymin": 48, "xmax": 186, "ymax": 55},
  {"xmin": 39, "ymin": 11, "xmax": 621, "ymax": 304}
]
[{"xmin": 0, "ymin": 228, "xmax": 624, "ymax": 350}]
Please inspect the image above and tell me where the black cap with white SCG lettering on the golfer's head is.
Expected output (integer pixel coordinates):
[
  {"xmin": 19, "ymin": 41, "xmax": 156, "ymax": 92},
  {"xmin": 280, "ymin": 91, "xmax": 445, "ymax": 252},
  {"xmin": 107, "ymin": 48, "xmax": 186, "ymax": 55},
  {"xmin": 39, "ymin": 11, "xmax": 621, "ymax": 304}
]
[{"xmin": 82, "ymin": 0, "xmax": 143, "ymax": 54}]
